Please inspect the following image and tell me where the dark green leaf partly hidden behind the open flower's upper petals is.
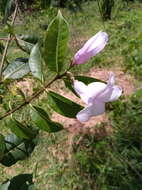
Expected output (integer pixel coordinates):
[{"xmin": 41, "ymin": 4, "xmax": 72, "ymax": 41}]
[{"xmin": 64, "ymin": 76, "xmax": 105, "ymax": 96}]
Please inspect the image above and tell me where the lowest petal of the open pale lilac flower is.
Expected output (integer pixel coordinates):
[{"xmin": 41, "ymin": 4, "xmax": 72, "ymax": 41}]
[{"xmin": 76, "ymin": 101, "xmax": 105, "ymax": 122}]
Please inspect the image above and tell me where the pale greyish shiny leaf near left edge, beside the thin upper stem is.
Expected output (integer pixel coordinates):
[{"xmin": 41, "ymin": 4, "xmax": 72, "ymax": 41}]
[{"xmin": 3, "ymin": 58, "xmax": 30, "ymax": 80}]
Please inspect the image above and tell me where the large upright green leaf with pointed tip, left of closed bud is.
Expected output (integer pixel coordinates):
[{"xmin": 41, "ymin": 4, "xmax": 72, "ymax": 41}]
[{"xmin": 44, "ymin": 11, "xmax": 69, "ymax": 73}]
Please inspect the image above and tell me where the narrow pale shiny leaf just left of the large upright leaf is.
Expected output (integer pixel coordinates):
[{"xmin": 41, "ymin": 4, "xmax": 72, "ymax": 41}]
[{"xmin": 29, "ymin": 44, "xmax": 43, "ymax": 81}]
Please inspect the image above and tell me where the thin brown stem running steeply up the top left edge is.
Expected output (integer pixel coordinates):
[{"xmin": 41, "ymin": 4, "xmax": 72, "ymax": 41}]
[{"xmin": 0, "ymin": 1, "xmax": 18, "ymax": 80}]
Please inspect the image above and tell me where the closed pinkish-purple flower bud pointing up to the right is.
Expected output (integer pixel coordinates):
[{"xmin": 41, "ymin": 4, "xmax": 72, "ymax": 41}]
[{"xmin": 73, "ymin": 31, "xmax": 108, "ymax": 65}]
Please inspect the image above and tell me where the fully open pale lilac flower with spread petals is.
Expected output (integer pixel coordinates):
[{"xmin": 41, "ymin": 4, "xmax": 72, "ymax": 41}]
[{"xmin": 74, "ymin": 72, "xmax": 122, "ymax": 122}]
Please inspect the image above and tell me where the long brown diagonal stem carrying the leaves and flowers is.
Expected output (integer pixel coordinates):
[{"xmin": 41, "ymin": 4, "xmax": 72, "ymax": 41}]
[{"xmin": 0, "ymin": 72, "xmax": 66, "ymax": 120}]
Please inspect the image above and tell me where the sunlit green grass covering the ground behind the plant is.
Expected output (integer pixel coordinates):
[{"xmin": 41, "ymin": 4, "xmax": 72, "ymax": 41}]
[{"xmin": 0, "ymin": 2, "xmax": 142, "ymax": 190}]
